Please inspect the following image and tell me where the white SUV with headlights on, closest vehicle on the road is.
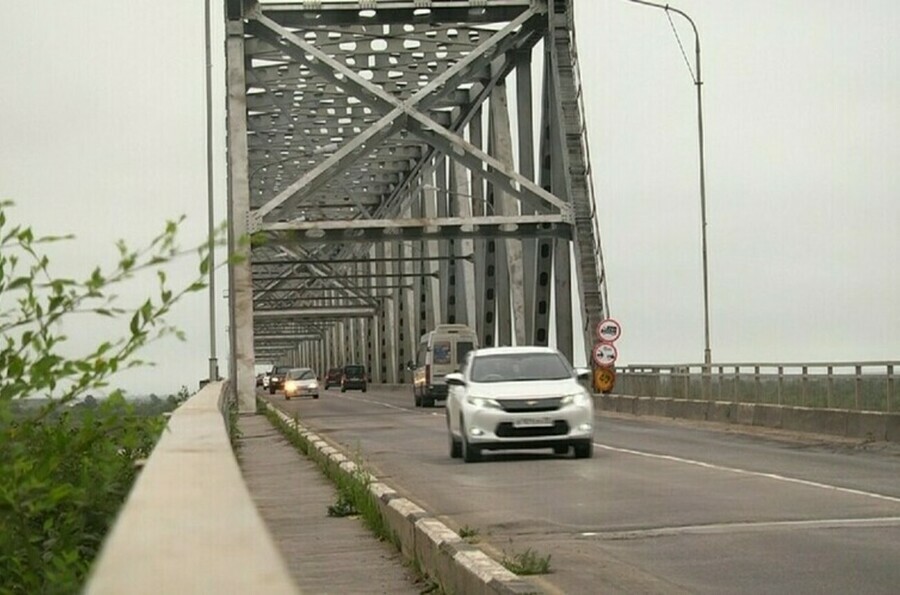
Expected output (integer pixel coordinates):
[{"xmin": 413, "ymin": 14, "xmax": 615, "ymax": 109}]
[{"xmin": 445, "ymin": 347, "xmax": 594, "ymax": 463}]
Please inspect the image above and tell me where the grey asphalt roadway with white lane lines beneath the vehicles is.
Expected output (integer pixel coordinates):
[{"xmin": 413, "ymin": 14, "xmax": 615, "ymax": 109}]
[{"xmin": 264, "ymin": 385, "xmax": 900, "ymax": 595}]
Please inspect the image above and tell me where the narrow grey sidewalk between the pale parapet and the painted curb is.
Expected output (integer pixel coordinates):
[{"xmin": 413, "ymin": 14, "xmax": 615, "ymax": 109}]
[{"xmin": 236, "ymin": 415, "xmax": 424, "ymax": 594}]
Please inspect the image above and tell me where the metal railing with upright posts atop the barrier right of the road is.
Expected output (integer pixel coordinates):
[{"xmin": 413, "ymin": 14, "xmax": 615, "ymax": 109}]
[{"xmin": 614, "ymin": 361, "xmax": 900, "ymax": 413}]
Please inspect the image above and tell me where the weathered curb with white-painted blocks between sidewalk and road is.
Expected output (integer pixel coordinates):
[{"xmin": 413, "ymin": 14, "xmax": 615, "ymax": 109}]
[{"xmin": 265, "ymin": 403, "xmax": 543, "ymax": 595}]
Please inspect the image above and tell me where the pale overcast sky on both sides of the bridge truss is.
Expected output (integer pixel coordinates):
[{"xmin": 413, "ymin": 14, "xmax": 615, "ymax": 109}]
[{"xmin": 0, "ymin": 0, "xmax": 900, "ymax": 393}]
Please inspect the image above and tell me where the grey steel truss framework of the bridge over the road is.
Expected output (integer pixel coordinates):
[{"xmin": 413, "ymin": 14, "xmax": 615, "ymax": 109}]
[{"xmin": 226, "ymin": 0, "xmax": 607, "ymax": 410}]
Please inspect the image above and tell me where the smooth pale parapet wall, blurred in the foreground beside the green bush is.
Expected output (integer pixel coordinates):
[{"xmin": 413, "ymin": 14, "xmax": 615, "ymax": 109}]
[{"xmin": 84, "ymin": 382, "xmax": 299, "ymax": 595}]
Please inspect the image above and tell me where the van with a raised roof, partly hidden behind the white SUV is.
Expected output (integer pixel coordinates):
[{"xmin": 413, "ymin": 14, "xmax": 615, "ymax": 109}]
[{"xmin": 410, "ymin": 324, "xmax": 478, "ymax": 407}]
